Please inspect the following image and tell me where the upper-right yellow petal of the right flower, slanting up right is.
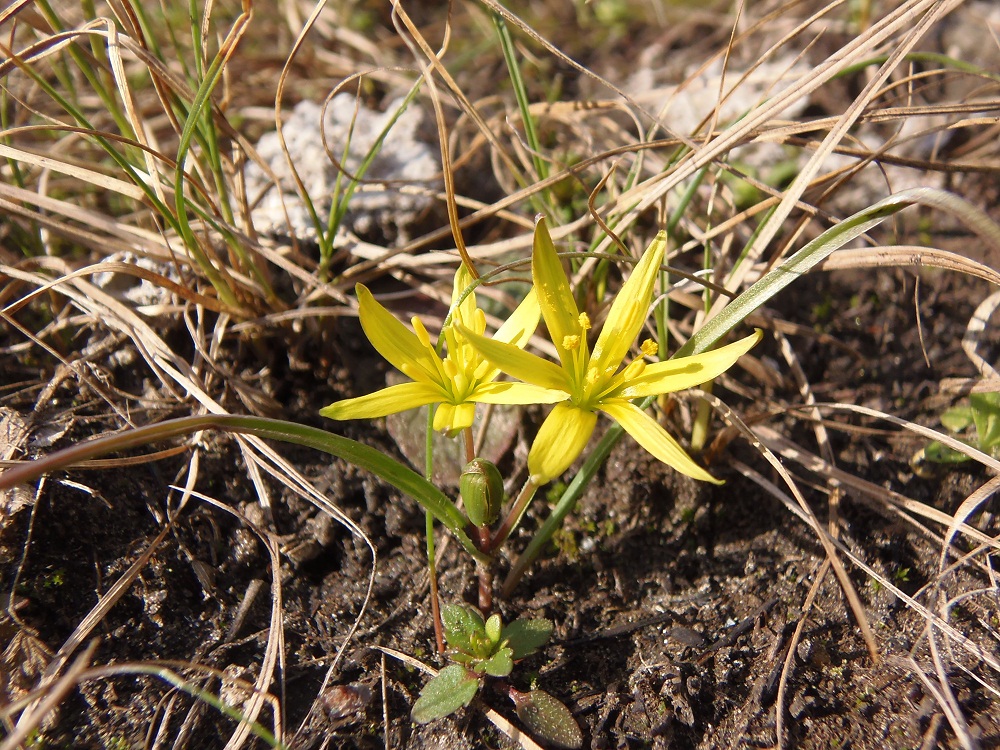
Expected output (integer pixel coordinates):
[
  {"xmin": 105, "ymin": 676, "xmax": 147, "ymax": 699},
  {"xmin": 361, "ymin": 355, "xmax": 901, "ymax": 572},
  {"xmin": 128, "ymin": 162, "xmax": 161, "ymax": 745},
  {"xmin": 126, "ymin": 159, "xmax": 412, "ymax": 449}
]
[{"xmin": 590, "ymin": 232, "xmax": 667, "ymax": 372}]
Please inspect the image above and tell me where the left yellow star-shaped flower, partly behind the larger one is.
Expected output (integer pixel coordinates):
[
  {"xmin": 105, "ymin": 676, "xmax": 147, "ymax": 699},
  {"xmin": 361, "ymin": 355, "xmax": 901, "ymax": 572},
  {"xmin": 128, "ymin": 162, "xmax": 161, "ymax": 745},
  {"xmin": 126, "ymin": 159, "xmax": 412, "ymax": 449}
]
[{"xmin": 320, "ymin": 265, "xmax": 566, "ymax": 434}]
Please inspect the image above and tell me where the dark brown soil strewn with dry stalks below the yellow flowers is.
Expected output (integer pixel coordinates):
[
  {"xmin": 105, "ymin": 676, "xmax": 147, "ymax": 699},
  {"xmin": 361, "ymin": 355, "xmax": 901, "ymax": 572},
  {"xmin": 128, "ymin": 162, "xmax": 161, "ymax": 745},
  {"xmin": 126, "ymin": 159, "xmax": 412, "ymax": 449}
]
[{"xmin": 0, "ymin": 1, "xmax": 1000, "ymax": 750}]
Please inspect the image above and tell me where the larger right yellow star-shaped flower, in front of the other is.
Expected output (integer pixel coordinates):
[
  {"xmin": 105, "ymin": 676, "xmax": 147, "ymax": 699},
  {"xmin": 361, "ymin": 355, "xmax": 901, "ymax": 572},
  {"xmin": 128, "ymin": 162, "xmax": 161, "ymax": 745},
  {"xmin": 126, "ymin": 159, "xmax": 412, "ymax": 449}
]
[{"xmin": 461, "ymin": 219, "xmax": 762, "ymax": 485}]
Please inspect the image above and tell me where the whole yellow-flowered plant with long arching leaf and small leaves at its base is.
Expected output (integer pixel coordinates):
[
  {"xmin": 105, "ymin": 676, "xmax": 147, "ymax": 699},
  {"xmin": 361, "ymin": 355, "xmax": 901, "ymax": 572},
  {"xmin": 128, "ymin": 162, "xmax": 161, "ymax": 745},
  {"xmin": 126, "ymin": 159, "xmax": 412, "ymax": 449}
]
[{"xmin": 0, "ymin": 218, "xmax": 761, "ymax": 747}]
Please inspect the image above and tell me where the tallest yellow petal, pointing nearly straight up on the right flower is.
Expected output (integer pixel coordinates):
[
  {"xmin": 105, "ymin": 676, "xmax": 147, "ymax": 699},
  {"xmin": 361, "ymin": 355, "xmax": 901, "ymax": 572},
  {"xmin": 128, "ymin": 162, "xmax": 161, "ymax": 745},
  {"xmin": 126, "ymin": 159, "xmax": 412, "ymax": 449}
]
[{"xmin": 531, "ymin": 216, "xmax": 586, "ymax": 368}]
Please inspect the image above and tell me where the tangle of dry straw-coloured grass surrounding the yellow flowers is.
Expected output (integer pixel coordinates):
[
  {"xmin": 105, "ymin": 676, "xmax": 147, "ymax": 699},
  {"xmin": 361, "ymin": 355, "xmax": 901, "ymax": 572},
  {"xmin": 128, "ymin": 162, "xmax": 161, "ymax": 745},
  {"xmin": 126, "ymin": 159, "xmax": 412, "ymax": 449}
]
[{"xmin": 0, "ymin": 0, "xmax": 1000, "ymax": 750}]
